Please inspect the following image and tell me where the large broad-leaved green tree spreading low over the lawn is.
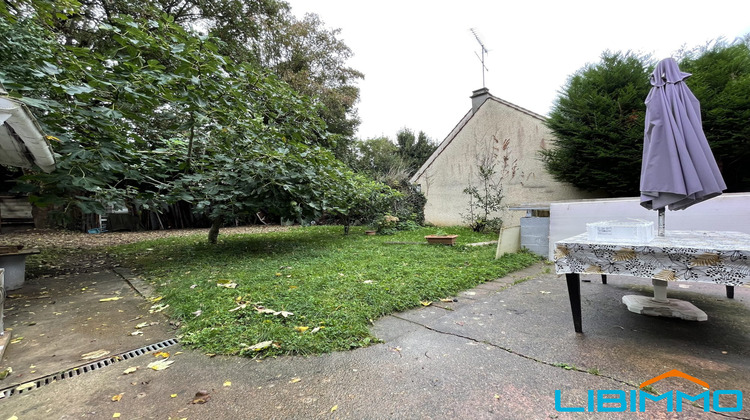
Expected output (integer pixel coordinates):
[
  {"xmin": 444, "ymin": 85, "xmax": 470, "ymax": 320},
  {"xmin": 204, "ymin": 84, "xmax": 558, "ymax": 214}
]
[{"xmin": 0, "ymin": 5, "xmax": 390, "ymax": 242}]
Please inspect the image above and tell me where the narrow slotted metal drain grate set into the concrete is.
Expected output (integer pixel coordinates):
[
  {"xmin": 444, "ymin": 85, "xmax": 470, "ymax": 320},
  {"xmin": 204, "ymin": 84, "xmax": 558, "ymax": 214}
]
[{"xmin": 0, "ymin": 338, "xmax": 178, "ymax": 399}]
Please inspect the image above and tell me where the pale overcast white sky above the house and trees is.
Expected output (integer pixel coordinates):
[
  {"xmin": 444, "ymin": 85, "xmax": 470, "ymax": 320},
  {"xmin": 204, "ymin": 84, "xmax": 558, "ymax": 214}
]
[{"xmin": 287, "ymin": 0, "xmax": 750, "ymax": 142}]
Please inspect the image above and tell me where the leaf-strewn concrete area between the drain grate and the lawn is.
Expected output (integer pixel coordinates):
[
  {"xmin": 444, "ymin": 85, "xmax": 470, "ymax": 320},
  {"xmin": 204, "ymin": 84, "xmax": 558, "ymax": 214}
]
[{"xmin": 0, "ymin": 270, "xmax": 175, "ymax": 388}]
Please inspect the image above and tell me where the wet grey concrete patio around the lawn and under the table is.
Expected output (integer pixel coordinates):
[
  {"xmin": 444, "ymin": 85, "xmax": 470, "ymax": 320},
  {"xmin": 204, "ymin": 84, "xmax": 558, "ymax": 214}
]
[{"xmin": 0, "ymin": 264, "xmax": 750, "ymax": 420}]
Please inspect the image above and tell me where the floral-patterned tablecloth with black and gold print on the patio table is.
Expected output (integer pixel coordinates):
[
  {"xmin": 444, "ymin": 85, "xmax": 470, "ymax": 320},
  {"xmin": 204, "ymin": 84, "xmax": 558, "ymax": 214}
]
[{"xmin": 555, "ymin": 231, "xmax": 750, "ymax": 286}]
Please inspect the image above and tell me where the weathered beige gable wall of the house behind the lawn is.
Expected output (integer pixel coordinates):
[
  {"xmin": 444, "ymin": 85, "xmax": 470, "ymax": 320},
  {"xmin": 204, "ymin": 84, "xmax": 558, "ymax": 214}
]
[{"xmin": 412, "ymin": 91, "xmax": 592, "ymax": 226}]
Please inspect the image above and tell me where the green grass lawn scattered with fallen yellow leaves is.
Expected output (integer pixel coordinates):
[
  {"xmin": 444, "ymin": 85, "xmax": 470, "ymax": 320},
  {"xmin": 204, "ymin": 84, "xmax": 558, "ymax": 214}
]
[{"xmin": 114, "ymin": 226, "xmax": 539, "ymax": 356}]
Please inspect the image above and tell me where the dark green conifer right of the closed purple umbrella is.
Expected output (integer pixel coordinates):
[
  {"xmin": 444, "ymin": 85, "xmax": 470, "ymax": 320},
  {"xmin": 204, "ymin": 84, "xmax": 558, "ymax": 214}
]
[{"xmin": 680, "ymin": 35, "xmax": 750, "ymax": 192}]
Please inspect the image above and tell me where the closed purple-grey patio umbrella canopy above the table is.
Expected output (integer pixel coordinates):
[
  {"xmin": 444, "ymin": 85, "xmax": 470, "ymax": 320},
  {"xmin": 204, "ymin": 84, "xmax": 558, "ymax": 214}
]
[{"xmin": 641, "ymin": 58, "xmax": 727, "ymax": 210}]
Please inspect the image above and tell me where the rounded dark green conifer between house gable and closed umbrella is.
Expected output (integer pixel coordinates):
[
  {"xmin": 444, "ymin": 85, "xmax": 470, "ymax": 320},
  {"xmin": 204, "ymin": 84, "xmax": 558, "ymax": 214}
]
[{"xmin": 542, "ymin": 52, "xmax": 651, "ymax": 196}]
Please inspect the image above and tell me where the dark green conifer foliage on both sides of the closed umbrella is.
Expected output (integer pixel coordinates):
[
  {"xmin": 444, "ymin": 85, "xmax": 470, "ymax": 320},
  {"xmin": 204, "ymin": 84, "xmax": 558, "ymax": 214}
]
[{"xmin": 542, "ymin": 39, "xmax": 750, "ymax": 196}]
